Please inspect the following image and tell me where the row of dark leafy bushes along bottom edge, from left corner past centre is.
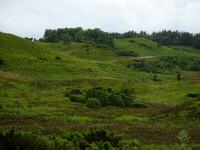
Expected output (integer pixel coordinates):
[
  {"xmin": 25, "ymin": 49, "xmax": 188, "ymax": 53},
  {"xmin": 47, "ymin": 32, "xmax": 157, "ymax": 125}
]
[{"xmin": 0, "ymin": 128, "xmax": 140, "ymax": 150}]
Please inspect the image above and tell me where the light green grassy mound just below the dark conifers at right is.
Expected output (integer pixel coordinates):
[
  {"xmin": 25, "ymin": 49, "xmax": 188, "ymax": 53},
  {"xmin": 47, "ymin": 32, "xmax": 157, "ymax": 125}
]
[{"xmin": 115, "ymin": 38, "xmax": 200, "ymax": 57}]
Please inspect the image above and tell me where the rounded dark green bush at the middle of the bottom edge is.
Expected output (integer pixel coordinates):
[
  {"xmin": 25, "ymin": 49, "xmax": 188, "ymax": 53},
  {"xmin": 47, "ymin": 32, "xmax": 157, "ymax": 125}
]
[{"xmin": 63, "ymin": 128, "xmax": 126, "ymax": 149}]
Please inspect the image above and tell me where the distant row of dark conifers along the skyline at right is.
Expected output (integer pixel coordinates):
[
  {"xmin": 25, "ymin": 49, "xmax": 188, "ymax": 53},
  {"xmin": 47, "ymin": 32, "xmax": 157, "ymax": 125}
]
[{"xmin": 111, "ymin": 30, "xmax": 200, "ymax": 48}]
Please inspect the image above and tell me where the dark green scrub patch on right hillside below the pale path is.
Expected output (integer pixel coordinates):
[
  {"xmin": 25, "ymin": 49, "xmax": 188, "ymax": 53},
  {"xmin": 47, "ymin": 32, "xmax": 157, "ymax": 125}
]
[{"xmin": 127, "ymin": 56, "xmax": 200, "ymax": 73}]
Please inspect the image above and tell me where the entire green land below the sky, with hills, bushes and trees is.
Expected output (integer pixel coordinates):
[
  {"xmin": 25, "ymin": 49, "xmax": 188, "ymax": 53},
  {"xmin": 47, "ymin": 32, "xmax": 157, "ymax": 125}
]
[{"xmin": 0, "ymin": 28, "xmax": 200, "ymax": 150}]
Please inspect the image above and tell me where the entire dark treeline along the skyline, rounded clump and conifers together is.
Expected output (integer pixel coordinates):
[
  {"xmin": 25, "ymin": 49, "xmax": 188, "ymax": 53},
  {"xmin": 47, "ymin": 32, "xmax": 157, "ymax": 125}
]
[{"xmin": 40, "ymin": 27, "xmax": 200, "ymax": 48}]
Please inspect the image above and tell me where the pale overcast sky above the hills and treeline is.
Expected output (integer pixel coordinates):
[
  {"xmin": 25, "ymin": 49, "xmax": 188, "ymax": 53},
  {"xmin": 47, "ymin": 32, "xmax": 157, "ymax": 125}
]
[{"xmin": 0, "ymin": 0, "xmax": 200, "ymax": 38}]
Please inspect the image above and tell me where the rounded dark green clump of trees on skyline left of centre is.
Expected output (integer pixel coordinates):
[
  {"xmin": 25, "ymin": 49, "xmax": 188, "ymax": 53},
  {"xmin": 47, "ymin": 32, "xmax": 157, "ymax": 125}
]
[{"xmin": 40, "ymin": 27, "xmax": 114, "ymax": 47}]
